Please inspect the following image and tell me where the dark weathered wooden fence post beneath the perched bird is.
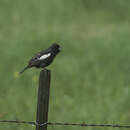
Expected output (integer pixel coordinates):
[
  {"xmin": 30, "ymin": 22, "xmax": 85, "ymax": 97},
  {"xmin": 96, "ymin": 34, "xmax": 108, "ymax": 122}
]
[{"xmin": 36, "ymin": 69, "xmax": 51, "ymax": 130}]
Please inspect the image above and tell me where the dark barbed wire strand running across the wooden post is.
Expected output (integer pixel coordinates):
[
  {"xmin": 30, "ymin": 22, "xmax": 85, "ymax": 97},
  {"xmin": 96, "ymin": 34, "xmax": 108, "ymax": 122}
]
[{"xmin": 0, "ymin": 120, "xmax": 130, "ymax": 128}]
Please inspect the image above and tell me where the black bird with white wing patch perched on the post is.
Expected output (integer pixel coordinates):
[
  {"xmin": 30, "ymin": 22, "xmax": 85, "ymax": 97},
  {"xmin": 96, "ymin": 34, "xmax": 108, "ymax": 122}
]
[{"xmin": 20, "ymin": 43, "xmax": 61, "ymax": 74}]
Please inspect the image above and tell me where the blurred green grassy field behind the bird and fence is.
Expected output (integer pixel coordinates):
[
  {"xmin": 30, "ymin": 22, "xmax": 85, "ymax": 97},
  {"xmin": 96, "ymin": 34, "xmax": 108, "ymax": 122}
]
[{"xmin": 0, "ymin": 0, "xmax": 130, "ymax": 130}]
